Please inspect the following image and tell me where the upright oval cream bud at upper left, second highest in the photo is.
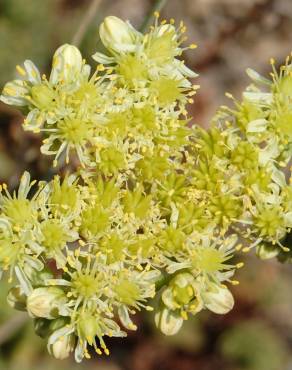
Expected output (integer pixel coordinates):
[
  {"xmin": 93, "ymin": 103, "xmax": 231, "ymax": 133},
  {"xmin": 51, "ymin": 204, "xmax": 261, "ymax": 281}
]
[{"xmin": 50, "ymin": 44, "xmax": 83, "ymax": 84}]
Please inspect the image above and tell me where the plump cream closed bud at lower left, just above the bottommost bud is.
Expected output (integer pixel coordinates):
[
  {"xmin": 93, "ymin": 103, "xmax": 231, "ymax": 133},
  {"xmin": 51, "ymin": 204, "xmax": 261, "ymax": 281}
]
[{"xmin": 27, "ymin": 287, "xmax": 67, "ymax": 319}]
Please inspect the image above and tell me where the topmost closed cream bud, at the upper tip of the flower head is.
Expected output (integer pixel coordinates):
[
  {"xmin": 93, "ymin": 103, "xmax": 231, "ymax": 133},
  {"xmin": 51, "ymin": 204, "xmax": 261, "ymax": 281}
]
[{"xmin": 99, "ymin": 16, "xmax": 139, "ymax": 52}]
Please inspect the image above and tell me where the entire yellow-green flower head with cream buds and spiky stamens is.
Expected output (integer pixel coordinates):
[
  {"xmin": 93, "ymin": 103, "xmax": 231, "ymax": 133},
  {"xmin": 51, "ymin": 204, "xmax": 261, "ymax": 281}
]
[{"xmin": 0, "ymin": 15, "xmax": 292, "ymax": 362}]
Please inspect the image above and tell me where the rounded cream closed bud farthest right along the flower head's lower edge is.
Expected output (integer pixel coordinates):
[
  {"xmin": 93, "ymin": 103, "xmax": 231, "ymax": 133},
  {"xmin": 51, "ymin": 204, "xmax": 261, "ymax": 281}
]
[{"xmin": 202, "ymin": 283, "xmax": 234, "ymax": 314}]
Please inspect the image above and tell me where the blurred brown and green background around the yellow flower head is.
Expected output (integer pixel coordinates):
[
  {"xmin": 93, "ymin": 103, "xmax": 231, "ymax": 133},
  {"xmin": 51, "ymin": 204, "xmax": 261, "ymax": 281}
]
[{"xmin": 0, "ymin": 0, "xmax": 292, "ymax": 370}]
